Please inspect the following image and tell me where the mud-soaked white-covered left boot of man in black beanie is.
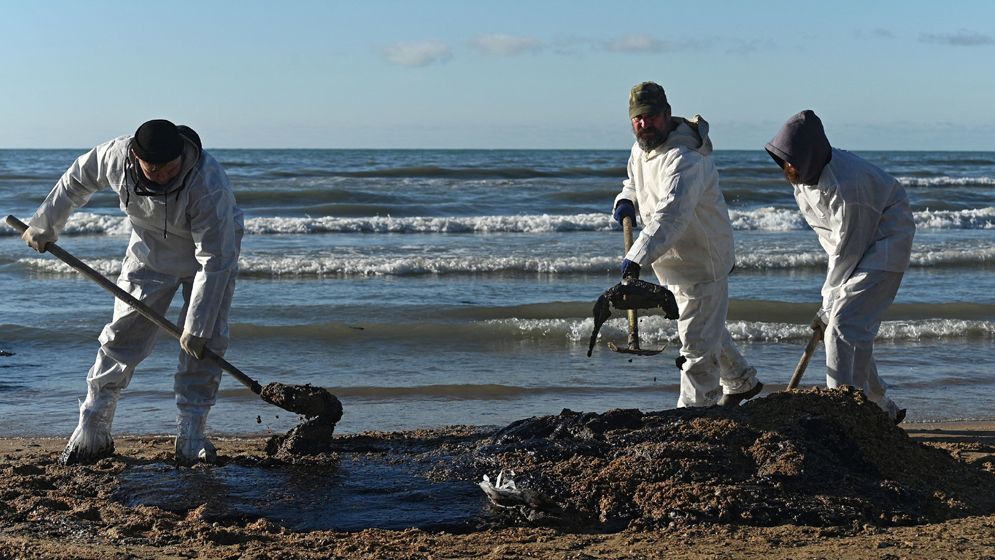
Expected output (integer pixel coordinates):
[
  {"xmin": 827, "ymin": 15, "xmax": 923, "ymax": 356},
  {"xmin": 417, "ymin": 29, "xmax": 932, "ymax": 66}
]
[{"xmin": 59, "ymin": 391, "xmax": 120, "ymax": 466}]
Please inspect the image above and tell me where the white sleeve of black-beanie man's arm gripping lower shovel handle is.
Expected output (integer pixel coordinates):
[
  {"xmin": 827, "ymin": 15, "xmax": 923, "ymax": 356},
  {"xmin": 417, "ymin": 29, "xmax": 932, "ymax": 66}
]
[{"xmin": 184, "ymin": 174, "xmax": 240, "ymax": 338}]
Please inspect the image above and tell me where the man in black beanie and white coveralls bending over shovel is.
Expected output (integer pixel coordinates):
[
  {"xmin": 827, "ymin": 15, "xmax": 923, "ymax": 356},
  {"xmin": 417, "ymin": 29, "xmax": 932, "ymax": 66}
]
[{"xmin": 22, "ymin": 120, "xmax": 243, "ymax": 465}]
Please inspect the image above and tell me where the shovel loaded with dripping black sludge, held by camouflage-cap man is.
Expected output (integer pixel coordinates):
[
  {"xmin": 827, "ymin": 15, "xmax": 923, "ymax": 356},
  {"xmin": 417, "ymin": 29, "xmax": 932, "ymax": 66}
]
[{"xmin": 587, "ymin": 217, "xmax": 680, "ymax": 358}]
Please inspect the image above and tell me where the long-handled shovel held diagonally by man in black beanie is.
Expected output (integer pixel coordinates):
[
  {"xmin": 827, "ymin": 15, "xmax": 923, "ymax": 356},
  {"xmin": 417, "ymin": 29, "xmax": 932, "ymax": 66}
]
[{"xmin": 7, "ymin": 216, "xmax": 342, "ymax": 423}]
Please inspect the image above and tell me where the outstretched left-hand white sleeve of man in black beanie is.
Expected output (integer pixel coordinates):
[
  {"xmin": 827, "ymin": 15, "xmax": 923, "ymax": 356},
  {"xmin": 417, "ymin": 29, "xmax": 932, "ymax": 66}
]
[{"xmin": 29, "ymin": 144, "xmax": 110, "ymax": 236}]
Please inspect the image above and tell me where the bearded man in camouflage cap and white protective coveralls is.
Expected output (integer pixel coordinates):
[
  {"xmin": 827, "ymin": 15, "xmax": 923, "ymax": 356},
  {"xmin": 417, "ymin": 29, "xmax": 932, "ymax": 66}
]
[{"xmin": 613, "ymin": 82, "xmax": 763, "ymax": 407}]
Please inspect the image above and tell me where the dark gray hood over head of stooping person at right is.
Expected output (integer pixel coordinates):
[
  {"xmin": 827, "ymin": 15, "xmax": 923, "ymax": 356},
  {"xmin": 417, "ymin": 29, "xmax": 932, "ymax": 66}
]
[{"xmin": 764, "ymin": 109, "xmax": 833, "ymax": 185}]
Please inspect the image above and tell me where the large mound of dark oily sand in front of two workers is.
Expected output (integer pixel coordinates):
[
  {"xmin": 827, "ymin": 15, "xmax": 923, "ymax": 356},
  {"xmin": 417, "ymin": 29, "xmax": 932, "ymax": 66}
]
[{"xmin": 470, "ymin": 388, "xmax": 995, "ymax": 531}]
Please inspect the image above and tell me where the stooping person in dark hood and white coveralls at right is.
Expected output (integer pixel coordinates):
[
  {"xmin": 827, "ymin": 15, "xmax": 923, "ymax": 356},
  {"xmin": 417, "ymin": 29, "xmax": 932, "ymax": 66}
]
[{"xmin": 765, "ymin": 110, "xmax": 916, "ymax": 423}]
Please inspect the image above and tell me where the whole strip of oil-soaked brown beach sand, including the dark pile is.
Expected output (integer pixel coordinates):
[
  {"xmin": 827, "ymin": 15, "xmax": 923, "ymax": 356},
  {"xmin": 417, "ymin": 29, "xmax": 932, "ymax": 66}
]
[{"xmin": 0, "ymin": 391, "xmax": 995, "ymax": 559}]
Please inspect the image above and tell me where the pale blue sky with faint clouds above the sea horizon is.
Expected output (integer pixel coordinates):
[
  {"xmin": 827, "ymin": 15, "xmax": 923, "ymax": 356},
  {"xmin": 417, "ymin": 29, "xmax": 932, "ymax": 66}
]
[{"xmin": 0, "ymin": 0, "xmax": 995, "ymax": 150}]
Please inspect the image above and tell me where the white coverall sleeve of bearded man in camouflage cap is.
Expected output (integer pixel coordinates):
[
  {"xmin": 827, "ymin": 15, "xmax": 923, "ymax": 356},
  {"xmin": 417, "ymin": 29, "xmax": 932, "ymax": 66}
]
[{"xmin": 625, "ymin": 153, "xmax": 704, "ymax": 266}]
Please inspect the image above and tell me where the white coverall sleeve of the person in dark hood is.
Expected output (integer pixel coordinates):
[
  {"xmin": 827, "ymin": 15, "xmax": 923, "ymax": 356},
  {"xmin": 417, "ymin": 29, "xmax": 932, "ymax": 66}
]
[{"xmin": 820, "ymin": 196, "xmax": 881, "ymax": 314}]
